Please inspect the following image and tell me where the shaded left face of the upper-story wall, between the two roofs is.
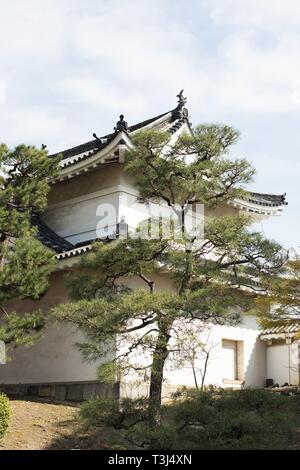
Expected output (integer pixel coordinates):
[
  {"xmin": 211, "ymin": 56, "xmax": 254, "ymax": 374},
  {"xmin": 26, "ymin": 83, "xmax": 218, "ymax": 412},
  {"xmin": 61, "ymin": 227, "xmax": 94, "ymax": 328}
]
[{"xmin": 43, "ymin": 164, "xmax": 122, "ymax": 244}]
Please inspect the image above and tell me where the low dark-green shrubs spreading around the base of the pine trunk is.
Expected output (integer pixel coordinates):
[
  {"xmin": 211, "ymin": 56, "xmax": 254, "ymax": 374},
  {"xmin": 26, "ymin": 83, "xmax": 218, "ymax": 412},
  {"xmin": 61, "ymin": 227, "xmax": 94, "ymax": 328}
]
[{"xmin": 81, "ymin": 387, "xmax": 299, "ymax": 450}]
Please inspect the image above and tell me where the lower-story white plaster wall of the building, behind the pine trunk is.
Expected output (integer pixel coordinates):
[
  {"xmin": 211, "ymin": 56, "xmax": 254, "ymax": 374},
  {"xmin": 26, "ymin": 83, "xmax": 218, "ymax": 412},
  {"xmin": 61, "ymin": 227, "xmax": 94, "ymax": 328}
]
[{"xmin": 0, "ymin": 317, "xmax": 268, "ymax": 396}]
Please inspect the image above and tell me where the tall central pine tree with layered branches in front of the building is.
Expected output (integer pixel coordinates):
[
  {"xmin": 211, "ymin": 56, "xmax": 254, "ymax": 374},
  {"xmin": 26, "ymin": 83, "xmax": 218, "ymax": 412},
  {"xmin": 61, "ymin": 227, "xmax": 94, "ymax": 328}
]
[{"xmin": 54, "ymin": 125, "xmax": 286, "ymax": 424}]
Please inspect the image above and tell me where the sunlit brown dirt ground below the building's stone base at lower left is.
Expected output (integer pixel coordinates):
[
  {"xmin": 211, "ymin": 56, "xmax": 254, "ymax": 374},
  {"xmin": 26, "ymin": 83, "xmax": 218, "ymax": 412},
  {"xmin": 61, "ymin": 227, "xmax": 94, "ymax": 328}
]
[{"xmin": 0, "ymin": 400, "xmax": 122, "ymax": 450}]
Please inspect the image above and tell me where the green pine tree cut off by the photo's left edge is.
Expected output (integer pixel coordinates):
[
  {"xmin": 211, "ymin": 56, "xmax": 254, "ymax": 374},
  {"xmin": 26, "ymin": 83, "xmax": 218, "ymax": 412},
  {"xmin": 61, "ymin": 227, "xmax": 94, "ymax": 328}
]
[{"xmin": 0, "ymin": 144, "xmax": 59, "ymax": 344}]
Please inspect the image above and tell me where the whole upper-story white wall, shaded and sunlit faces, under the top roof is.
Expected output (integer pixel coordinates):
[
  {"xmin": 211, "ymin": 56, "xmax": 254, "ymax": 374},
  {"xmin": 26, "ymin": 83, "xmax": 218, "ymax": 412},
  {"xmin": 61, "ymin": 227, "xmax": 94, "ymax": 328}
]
[{"xmin": 43, "ymin": 163, "xmax": 253, "ymax": 244}]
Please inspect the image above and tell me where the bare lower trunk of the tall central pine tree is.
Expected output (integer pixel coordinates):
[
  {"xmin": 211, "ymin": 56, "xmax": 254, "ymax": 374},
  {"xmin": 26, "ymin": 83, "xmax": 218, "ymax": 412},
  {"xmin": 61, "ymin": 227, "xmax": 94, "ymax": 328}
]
[{"xmin": 149, "ymin": 319, "xmax": 173, "ymax": 426}]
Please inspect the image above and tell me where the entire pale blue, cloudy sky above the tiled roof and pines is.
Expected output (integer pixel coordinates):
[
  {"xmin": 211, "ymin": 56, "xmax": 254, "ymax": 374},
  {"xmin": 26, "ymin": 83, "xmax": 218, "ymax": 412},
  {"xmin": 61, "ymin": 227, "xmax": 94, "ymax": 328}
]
[{"xmin": 0, "ymin": 0, "xmax": 300, "ymax": 249}]
